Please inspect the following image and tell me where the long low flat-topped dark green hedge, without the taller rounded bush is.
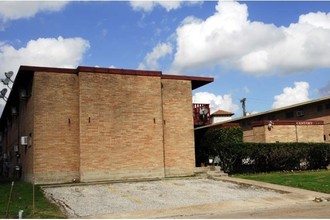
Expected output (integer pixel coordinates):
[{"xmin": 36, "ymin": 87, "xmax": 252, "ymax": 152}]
[{"xmin": 214, "ymin": 143, "xmax": 330, "ymax": 173}]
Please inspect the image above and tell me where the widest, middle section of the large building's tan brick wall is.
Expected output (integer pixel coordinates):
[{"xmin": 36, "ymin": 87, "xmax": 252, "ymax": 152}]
[{"xmin": 79, "ymin": 72, "xmax": 164, "ymax": 181}]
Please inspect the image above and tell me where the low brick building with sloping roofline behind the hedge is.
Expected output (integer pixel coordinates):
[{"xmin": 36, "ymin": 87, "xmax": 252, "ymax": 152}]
[{"xmin": 198, "ymin": 96, "xmax": 330, "ymax": 143}]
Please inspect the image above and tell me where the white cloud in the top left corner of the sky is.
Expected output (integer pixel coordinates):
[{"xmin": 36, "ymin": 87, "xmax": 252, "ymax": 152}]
[{"xmin": 0, "ymin": 1, "xmax": 68, "ymax": 21}]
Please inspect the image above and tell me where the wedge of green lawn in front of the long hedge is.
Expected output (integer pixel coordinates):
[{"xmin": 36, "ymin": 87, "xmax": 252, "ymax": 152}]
[{"xmin": 235, "ymin": 170, "xmax": 330, "ymax": 193}]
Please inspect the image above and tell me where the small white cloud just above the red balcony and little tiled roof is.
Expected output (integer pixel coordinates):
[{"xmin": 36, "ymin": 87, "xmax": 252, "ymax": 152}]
[{"xmin": 193, "ymin": 92, "xmax": 239, "ymax": 114}]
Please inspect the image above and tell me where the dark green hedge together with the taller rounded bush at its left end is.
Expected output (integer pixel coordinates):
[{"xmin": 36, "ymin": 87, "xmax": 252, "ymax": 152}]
[{"xmin": 196, "ymin": 127, "xmax": 330, "ymax": 173}]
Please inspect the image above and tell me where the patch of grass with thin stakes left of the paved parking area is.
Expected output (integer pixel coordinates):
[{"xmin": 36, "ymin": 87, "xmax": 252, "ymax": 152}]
[{"xmin": 0, "ymin": 182, "xmax": 66, "ymax": 219}]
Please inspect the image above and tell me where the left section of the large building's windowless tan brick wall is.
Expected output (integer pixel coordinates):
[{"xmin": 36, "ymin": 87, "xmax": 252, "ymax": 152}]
[{"xmin": 32, "ymin": 72, "xmax": 79, "ymax": 183}]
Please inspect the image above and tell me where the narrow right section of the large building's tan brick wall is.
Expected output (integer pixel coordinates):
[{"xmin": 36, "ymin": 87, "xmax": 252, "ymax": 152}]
[{"xmin": 162, "ymin": 79, "xmax": 195, "ymax": 177}]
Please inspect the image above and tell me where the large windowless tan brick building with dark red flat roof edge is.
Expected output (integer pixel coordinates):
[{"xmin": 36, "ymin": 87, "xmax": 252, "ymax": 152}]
[{"xmin": 0, "ymin": 66, "xmax": 213, "ymax": 183}]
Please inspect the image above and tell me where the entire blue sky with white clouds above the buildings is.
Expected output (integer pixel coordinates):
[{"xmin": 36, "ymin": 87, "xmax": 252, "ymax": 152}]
[{"xmin": 0, "ymin": 0, "xmax": 330, "ymax": 117}]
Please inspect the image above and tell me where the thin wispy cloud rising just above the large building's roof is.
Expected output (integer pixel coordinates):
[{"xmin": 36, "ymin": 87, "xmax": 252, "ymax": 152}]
[{"xmin": 138, "ymin": 43, "xmax": 172, "ymax": 70}]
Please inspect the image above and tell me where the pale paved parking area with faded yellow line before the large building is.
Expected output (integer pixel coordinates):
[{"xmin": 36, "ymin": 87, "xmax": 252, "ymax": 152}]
[{"xmin": 44, "ymin": 177, "xmax": 330, "ymax": 218}]
